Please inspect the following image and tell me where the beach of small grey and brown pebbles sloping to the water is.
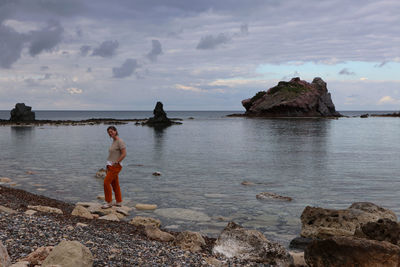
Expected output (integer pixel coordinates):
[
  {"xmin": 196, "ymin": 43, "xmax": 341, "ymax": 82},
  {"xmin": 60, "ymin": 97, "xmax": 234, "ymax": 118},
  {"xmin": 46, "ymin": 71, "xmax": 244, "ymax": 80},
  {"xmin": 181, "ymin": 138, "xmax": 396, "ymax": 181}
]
[{"xmin": 0, "ymin": 185, "xmax": 262, "ymax": 266}]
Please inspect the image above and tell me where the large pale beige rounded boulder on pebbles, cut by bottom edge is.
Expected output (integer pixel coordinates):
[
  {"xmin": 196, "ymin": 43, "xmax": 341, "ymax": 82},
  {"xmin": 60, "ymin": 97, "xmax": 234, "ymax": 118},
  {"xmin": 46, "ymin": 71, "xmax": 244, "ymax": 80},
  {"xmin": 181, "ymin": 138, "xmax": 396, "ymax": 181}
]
[{"xmin": 42, "ymin": 240, "xmax": 93, "ymax": 267}]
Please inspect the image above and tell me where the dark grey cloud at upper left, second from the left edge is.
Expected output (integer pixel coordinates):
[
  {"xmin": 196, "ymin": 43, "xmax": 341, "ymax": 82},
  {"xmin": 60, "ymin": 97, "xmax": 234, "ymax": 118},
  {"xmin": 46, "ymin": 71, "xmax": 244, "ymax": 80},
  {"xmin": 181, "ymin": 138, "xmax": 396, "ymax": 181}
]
[{"xmin": 28, "ymin": 20, "xmax": 64, "ymax": 56}]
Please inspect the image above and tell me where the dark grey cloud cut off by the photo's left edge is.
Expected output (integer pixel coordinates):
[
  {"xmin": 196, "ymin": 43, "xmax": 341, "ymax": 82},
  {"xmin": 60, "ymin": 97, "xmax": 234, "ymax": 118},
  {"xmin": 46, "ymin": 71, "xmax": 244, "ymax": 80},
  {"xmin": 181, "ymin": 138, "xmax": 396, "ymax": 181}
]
[{"xmin": 0, "ymin": 24, "xmax": 25, "ymax": 68}]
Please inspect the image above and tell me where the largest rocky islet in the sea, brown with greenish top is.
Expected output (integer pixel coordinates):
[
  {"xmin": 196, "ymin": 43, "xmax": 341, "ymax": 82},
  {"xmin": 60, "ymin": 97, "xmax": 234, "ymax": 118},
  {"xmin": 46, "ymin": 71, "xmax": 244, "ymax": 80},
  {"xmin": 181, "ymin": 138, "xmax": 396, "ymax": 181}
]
[{"xmin": 242, "ymin": 77, "xmax": 342, "ymax": 117}]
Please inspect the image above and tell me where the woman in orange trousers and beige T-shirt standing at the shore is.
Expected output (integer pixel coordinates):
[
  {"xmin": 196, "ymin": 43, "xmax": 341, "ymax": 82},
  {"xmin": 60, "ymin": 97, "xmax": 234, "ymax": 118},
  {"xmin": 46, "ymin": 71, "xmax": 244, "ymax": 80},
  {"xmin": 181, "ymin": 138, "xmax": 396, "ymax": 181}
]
[{"xmin": 102, "ymin": 126, "xmax": 126, "ymax": 209}]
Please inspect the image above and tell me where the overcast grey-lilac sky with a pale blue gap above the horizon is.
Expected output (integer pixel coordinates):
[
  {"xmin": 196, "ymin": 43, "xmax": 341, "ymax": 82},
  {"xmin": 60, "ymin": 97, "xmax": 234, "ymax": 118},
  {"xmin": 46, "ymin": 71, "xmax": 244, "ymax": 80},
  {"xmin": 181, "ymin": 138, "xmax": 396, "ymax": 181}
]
[{"xmin": 0, "ymin": 0, "xmax": 400, "ymax": 111}]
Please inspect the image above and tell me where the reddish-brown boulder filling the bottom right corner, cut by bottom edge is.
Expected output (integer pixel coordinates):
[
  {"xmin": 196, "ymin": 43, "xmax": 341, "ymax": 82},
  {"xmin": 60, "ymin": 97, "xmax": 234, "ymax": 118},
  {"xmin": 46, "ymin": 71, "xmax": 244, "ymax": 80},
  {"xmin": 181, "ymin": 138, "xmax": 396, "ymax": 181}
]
[{"xmin": 304, "ymin": 237, "xmax": 400, "ymax": 267}]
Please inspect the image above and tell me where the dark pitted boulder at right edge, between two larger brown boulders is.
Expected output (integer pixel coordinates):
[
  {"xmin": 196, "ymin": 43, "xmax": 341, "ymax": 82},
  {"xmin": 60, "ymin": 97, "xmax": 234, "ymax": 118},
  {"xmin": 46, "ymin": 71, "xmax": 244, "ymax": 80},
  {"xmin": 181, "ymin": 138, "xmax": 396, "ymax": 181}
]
[{"xmin": 354, "ymin": 219, "xmax": 400, "ymax": 246}]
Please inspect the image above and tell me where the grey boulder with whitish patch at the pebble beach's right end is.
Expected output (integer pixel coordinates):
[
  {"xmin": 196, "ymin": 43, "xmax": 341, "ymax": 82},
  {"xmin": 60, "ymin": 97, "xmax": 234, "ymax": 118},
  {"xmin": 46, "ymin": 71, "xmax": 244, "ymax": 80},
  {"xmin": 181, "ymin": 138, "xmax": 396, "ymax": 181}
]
[{"xmin": 212, "ymin": 222, "xmax": 293, "ymax": 266}]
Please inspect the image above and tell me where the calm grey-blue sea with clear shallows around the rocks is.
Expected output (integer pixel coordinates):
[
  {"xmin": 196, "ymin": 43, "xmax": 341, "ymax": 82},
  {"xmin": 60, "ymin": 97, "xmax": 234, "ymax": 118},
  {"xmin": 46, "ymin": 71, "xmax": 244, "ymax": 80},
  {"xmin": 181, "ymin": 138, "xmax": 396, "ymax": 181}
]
[{"xmin": 0, "ymin": 111, "xmax": 400, "ymax": 246}]
